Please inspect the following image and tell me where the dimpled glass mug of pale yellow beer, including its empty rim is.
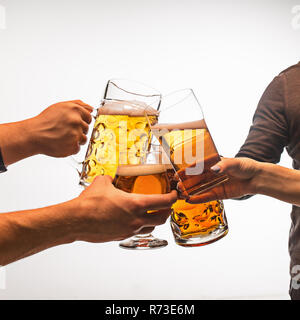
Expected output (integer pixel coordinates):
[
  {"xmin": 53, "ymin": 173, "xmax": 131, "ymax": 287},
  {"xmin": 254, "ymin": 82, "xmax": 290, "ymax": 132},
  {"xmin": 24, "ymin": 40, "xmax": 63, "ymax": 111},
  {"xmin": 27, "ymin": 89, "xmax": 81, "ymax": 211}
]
[{"xmin": 80, "ymin": 79, "xmax": 161, "ymax": 187}]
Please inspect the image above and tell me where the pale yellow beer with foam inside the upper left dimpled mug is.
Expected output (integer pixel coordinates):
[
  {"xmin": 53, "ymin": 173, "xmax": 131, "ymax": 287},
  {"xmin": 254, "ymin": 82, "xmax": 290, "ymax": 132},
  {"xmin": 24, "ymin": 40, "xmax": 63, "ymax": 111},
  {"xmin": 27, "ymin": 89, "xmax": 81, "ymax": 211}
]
[{"xmin": 81, "ymin": 100, "xmax": 157, "ymax": 185}]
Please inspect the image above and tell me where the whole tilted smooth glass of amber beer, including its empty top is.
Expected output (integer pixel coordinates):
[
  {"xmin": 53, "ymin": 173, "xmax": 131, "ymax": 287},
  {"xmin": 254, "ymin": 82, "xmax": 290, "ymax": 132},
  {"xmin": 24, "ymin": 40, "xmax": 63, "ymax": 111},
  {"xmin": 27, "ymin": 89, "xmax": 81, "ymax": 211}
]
[{"xmin": 146, "ymin": 89, "xmax": 228, "ymax": 197}]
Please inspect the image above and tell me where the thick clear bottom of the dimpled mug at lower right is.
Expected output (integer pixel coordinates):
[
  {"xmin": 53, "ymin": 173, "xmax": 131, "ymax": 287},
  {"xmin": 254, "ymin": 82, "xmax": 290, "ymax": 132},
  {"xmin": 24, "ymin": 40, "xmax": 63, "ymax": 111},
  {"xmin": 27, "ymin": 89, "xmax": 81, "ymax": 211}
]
[{"xmin": 174, "ymin": 226, "xmax": 229, "ymax": 247}]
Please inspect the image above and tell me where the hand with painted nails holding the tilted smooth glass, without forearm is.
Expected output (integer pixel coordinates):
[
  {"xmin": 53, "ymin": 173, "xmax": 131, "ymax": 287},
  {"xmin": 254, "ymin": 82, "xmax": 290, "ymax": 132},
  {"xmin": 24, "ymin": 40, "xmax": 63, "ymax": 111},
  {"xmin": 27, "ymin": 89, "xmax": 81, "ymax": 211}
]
[{"xmin": 187, "ymin": 158, "xmax": 260, "ymax": 203}]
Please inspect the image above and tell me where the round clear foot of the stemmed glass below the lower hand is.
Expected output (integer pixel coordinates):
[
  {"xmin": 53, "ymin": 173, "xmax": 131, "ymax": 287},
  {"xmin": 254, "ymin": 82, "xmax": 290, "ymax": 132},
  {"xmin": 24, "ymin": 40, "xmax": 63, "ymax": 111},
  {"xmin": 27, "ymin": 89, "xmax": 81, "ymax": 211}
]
[{"xmin": 119, "ymin": 234, "xmax": 168, "ymax": 250}]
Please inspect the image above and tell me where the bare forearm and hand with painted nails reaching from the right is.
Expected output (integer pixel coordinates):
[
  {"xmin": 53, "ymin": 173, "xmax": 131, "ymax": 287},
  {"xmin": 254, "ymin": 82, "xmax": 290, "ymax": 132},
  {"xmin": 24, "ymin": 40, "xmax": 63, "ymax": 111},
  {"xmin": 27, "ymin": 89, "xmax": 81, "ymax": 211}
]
[{"xmin": 188, "ymin": 158, "xmax": 300, "ymax": 206}]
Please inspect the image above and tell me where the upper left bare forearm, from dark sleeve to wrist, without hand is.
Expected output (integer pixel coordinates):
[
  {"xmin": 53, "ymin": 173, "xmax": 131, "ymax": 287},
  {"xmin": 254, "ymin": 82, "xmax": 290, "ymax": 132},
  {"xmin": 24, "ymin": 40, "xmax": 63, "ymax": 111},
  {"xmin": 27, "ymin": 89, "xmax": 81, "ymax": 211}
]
[{"xmin": 0, "ymin": 118, "xmax": 39, "ymax": 166}]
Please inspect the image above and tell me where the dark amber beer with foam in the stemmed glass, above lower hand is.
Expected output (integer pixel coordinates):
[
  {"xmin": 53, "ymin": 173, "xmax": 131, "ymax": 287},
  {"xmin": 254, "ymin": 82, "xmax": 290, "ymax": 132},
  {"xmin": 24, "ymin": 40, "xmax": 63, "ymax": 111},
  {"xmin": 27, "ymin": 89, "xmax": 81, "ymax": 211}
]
[{"xmin": 114, "ymin": 164, "xmax": 171, "ymax": 198}]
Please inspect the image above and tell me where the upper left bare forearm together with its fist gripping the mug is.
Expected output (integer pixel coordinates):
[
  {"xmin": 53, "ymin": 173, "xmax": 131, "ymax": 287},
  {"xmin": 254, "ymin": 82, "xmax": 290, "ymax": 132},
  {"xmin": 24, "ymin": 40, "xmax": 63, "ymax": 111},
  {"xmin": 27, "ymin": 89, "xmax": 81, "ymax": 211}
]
[{"xmin": 0, "ymin": 100, "xmax": 93, "ymax": 166}]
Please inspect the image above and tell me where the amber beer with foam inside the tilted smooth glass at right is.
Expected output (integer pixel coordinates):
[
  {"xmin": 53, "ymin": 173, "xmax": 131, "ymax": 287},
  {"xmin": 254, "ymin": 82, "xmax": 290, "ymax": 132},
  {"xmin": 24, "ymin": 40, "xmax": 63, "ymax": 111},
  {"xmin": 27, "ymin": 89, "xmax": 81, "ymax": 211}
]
[{"xmin": 152, "ymin": 120, "xmax": 228, "ymax": 196}]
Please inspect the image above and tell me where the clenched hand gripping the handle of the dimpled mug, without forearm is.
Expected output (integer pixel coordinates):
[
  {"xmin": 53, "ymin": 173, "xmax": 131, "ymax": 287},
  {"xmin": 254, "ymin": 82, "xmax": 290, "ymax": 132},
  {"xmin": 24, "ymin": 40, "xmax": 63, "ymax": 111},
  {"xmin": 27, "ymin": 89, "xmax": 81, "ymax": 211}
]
[{"xmin": 30, "ymin": 100, "xmax": 93, "ymax": 157}]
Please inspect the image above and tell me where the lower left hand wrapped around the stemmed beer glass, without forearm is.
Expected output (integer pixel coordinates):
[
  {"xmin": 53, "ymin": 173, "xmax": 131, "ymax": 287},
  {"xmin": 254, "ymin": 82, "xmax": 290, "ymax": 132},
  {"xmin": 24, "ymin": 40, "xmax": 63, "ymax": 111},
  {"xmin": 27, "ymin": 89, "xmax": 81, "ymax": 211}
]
[{"xmin": 70, "ymin": 176, "xmax": 177, "ymax": 242}]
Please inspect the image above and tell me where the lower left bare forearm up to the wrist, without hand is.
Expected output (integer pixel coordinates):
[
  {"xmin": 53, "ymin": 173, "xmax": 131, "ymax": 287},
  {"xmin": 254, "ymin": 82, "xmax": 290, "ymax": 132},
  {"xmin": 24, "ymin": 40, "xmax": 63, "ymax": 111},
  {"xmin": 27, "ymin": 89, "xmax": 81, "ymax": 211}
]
[{"xmin": 0, "ymin": 200, "xmax": 79, "ymax": 266}]
